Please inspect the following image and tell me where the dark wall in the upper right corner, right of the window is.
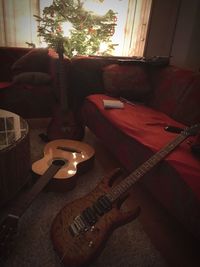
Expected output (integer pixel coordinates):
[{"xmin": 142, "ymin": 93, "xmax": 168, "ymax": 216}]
[{"xmin": 171, "ymin": 0, "xmax": 200, "ymax": 70}]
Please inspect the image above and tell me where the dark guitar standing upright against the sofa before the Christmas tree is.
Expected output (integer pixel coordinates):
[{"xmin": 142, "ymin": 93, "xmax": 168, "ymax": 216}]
[{"xmin": 47, "ymin": 38, "xmax": 84, "ymax": 141}]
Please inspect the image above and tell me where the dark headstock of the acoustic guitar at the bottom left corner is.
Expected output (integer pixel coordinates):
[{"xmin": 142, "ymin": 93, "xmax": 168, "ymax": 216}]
[{"xmin": 0, "ymin": 215, "xmax": 19, "ymax": 260}]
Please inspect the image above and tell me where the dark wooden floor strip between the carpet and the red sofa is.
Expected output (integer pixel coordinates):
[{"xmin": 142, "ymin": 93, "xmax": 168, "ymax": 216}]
[{"xmin": 87, "ymin": 127, "xmax": 200, "ymax": 267}]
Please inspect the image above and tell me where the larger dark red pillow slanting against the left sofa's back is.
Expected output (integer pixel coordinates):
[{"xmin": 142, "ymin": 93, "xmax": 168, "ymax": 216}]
[{"xmin": 11, "ymin": 48, "xmax": 49, "ymax": 75}]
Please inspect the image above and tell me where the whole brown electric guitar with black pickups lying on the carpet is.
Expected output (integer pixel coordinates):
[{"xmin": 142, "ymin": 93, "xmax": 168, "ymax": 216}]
[{"xmin": 51, "ymin": 124, "xmax": 200, "ymax": 267}]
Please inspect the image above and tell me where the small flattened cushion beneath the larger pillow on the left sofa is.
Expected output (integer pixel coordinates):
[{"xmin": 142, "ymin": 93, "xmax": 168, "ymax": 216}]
[{"xmin": 13, "ymin": 72, "xmax": 51, "ymax": 85}]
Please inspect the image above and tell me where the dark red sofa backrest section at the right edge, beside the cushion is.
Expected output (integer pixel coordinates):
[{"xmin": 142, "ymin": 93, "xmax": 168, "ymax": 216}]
[{"xmin": 148, "ymin": 66, "xmax": 200, "ymax": 125}]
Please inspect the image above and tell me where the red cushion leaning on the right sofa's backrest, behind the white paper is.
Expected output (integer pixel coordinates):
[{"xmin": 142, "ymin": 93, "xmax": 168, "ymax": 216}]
[{"xmin": 103, "ymin": 64, "xmax": 151, "ymax": 102}]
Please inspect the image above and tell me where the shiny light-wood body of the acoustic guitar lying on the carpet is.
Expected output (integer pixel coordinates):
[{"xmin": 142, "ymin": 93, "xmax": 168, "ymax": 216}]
[{"xmin": 32, "ymin": 139, "xmax": 95, "ymax": 192}]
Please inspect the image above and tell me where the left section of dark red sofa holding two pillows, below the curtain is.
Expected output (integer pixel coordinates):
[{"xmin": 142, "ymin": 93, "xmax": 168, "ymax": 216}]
[{"xmin": 0, "ymin": 47, "xmax": 70, "ymax": 118}]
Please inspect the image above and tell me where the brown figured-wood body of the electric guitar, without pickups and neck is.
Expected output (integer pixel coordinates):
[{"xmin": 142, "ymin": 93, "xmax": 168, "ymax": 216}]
[{"xmin": 51, "ymin": 170, "xmax": 139, "ymax": 267}]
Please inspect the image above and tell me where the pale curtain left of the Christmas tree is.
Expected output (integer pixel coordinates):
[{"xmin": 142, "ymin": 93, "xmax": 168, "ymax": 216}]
[{"xmin": 0, "ymin": 0, "xmax": 39, "ymax": 47}]
